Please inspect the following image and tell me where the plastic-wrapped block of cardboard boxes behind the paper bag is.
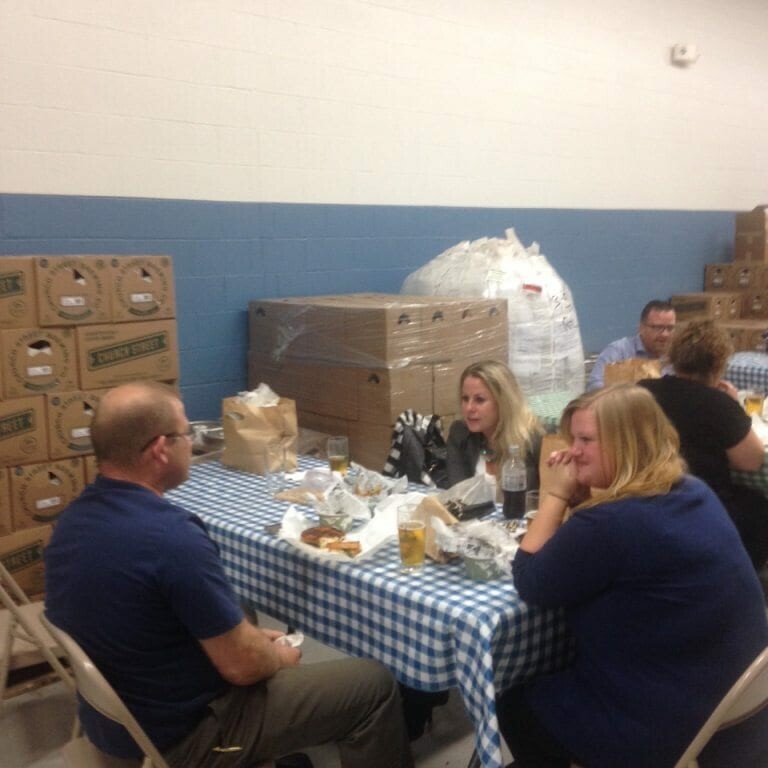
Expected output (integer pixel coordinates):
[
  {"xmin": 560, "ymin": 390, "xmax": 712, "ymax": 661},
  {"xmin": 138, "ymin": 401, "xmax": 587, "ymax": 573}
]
[{"xmin": 248, "ymin": 294, "xmax": 509, "ymax": 470}]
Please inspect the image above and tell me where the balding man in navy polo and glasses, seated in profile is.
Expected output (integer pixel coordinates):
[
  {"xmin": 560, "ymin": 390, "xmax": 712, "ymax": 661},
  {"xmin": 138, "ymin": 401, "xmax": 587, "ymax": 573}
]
[{"xmin": 45, "ymin": 382, "xmax": 412, "ymax": 768}]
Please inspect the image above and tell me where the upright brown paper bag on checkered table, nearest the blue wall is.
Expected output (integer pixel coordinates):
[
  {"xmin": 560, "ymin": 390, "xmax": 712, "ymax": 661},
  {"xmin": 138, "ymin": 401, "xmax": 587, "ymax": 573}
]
[{"xmin": 221, "ymin": 397, "xmax": 299, "ymax": 475}]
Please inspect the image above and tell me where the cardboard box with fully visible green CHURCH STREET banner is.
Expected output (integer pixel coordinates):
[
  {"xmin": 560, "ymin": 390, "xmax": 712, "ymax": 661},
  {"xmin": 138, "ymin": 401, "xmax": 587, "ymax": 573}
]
[{"xmin": 77, "ymin": 320, "xmax": 179, "ymax": 391}]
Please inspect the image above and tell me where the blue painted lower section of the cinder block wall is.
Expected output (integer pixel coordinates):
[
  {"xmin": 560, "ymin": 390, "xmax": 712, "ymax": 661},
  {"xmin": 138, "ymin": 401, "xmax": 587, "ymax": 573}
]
[{"xmin": 0, "ymin": 194, "xmax": 734, "ymax": 419}]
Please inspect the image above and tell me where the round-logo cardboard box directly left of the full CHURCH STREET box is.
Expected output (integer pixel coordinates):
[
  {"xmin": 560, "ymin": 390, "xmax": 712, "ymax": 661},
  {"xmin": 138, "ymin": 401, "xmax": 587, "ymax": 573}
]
[{"xmin": 0, "ymin": 328, "xmax": 79, "ymax": 398}]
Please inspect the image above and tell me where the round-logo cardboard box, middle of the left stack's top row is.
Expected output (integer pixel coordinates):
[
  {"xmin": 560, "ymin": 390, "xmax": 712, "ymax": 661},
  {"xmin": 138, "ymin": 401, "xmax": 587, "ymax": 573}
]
[{"xmin": 35, "ymin": 256, "xmax": 112, "ymax": 326}]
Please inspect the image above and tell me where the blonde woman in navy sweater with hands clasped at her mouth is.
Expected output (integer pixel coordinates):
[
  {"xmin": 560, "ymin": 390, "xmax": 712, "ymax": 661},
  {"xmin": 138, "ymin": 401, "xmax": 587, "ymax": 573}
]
[{"xmin": 498, "ymin": 385, "xmax": 768, "ymax": 768}]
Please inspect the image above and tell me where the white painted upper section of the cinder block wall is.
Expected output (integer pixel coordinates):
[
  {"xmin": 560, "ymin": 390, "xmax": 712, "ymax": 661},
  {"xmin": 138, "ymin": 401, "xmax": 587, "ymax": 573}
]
[{"xmin": 0, "ymin": 0, "xmax": 768, "ymax": 210}]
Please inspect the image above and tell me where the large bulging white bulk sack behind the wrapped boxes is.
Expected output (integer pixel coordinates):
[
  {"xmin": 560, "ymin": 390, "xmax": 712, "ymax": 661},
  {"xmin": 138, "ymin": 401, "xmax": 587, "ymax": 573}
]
[{"xmin": 400, "ymin": 229, "xmax": 584, "ymax": 395}]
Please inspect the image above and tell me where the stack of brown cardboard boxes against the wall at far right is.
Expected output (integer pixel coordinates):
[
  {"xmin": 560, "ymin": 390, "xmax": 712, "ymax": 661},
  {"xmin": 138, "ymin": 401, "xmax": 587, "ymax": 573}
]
[{"xmin": 672, "ymin": 206, "xmax": 768, "ymax": 352}]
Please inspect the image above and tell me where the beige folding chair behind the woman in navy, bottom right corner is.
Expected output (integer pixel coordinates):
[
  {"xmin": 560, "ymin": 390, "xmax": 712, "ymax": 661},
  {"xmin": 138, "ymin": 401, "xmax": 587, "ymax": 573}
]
[{"xmin": 675, "ymin": 648, "xmax": 768, "ymax": 768}]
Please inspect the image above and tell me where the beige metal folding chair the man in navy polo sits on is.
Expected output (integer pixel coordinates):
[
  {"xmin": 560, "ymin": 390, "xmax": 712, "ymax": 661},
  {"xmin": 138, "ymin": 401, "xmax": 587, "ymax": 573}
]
[{"xmin": 40, "ymin": 614, "xmax": 168, "ymax": 768}]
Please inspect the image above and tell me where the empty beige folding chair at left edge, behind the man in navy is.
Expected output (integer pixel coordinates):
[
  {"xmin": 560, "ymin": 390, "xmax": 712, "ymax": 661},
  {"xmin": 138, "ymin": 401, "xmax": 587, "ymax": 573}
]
[{"xmin": 0, "ymin": 562, "xmax": 75, "ymax": 700}]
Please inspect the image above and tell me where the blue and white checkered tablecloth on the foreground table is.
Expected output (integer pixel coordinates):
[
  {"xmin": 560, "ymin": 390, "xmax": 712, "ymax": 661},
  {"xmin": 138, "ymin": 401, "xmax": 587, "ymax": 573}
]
[{"xmin": 168, "ymin": 458, "xmax": 571, "ymax": 768}]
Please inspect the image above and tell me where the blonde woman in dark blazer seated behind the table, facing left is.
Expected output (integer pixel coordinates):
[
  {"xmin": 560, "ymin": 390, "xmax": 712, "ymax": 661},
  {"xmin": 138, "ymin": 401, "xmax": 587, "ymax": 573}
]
[{"xmin": 440, "ymin": 360, "xmax": 542, "ymax": 488}]
